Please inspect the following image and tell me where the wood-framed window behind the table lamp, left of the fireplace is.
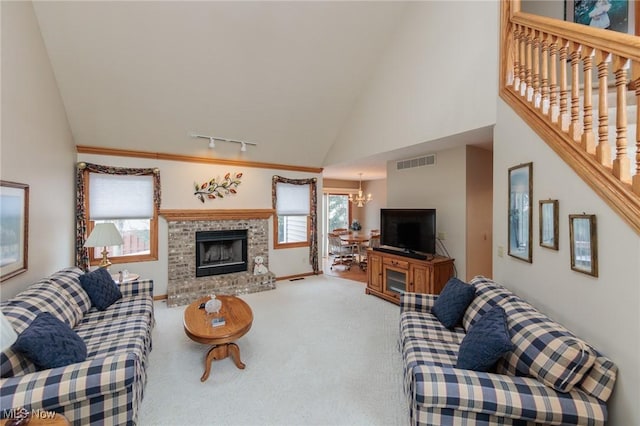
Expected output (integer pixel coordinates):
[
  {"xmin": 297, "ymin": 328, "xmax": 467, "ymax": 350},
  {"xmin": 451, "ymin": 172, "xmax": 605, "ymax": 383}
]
[{"xmin": 84, "ymin": 170, "xmax": 158, "ymax": 264}]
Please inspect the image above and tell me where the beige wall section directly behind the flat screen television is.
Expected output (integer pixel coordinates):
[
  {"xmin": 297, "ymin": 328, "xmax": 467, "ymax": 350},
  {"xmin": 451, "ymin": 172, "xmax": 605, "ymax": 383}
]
[{"xmin": 387, "ymin": 146, "xmax": 466, "ymax": 279}]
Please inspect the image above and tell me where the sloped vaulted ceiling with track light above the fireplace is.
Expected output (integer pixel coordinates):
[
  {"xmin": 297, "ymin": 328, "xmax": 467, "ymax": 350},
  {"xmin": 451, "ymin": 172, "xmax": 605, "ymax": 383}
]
[{"xmin": 34, "ymin": 1, "xmax": 405, "ymax": 178}]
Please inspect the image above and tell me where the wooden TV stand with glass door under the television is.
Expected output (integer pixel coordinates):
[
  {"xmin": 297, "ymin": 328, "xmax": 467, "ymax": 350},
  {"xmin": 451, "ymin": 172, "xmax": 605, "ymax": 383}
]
[{"xmin": 366, "ymin": 249, "xmax": 454, "ymax": 304}]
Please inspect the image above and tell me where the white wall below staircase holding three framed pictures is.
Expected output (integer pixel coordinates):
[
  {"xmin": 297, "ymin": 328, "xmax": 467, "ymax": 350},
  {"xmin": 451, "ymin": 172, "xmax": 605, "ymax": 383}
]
[{"xmin": 493, "ymin": 100, "xmax": 640, "ymax": 425}]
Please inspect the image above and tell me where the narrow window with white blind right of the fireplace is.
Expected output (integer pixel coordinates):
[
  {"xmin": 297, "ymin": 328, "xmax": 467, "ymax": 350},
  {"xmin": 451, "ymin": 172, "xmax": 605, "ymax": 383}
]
[{"xmin": 274, "ymin": 182, "xmax": 311, "ymax": 249}]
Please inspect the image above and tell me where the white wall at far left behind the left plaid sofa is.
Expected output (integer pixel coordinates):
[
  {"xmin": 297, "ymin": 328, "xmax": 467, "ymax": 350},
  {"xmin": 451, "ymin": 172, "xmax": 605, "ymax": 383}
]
[{"xmin": 0, "ymin": 1, "xmax": 75, "ymax": 300}]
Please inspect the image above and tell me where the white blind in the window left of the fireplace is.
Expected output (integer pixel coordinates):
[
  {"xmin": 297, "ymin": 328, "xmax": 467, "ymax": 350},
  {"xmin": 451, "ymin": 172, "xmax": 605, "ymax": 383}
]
[{"xmin": 89, "ymin": 173, "xmax": 153, "ymax": 220}]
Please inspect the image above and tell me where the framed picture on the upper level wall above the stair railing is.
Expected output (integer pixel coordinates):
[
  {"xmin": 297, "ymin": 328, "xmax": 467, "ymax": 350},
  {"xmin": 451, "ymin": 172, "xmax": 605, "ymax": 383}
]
[{"xmin": 564, "ymin": 0, "xmax": 637, "ymax": 34}]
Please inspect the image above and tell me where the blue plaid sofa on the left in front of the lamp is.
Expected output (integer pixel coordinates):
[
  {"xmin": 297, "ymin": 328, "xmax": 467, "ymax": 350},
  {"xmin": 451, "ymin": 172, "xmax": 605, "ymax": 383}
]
[{"xmin": 0, "ymin": 267, "xmax": 154, "ymax": 425}]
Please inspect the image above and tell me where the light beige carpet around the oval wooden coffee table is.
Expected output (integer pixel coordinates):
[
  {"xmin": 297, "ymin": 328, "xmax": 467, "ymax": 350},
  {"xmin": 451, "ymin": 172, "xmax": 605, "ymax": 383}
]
[{"xmin": 139, "ymin": 276, "xmax": 408, "ymax": 425}]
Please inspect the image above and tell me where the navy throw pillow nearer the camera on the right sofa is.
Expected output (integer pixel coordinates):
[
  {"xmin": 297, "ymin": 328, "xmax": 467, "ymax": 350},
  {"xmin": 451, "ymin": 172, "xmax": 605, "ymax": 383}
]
[{"xmin": 456, "ymin": 306, "xmax": 514, "ymax": 372}]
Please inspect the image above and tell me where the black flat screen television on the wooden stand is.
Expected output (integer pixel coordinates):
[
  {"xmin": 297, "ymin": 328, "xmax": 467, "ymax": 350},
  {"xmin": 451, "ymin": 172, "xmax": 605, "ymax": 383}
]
[{"xmin": 380, "ymin": 209, "xmax": 436, "ymax": 255}]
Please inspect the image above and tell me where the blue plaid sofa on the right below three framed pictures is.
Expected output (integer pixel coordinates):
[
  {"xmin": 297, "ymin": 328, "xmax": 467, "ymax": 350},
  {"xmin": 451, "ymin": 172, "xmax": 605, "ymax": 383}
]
[{"xmin": 398, "ymin": 276, "xmax": 617, "ymax": 425}]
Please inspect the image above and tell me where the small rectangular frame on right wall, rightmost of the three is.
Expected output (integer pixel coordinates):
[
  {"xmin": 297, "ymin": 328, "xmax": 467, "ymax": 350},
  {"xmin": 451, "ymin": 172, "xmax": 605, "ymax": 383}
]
[{"xmin": 569, "ymin": 213, "xmax": 598, "ymax": 277}]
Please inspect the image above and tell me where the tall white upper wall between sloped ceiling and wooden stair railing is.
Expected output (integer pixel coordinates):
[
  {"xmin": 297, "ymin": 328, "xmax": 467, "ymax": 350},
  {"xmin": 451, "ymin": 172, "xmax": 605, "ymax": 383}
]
[{"xmin": 324, "ymin": 1, "xmax": 499, "ymax": 164}]
